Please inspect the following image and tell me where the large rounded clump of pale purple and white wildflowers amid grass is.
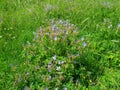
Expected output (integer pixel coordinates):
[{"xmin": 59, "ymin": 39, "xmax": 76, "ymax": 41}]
[{"xmin": 22, "ymin": 20, "xmax": 87, "ymax": 90}]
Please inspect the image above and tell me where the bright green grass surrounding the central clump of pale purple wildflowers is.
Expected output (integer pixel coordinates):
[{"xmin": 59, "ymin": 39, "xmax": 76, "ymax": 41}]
[{"xmin": 0, "ymin": 0, "xmax": 120, "ymax": 90}]
